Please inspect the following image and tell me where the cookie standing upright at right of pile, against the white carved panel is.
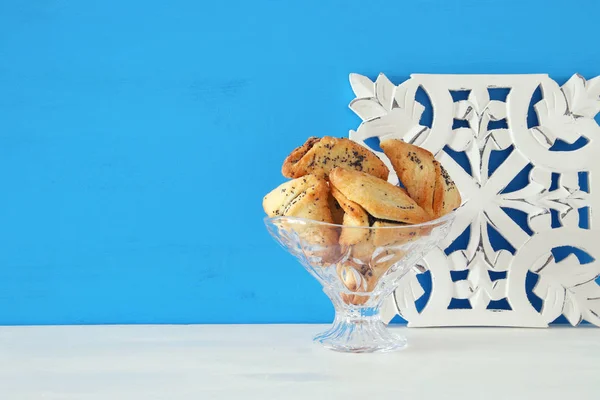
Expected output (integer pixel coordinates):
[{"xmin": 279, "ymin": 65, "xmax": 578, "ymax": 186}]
[{"xmin": 380, "ymin": 139, "xmax": 437, "ymax": 215}]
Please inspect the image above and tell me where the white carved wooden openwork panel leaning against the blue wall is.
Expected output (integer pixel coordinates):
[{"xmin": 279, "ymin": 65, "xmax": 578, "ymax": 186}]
[{"xmin": 350, "ymin": 74, "xmax": 600, "ymax": 327}]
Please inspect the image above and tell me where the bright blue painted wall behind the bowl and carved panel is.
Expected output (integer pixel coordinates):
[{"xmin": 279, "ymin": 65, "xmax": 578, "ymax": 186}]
[{"xmin": 0, "ymin": 0, "xmax": 600, "ymax": 324}]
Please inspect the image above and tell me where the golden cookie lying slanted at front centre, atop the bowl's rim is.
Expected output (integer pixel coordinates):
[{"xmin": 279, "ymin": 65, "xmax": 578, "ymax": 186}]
[{"xmin": 329, "ymin": 168, "xmax": 431, "ymax": 224}]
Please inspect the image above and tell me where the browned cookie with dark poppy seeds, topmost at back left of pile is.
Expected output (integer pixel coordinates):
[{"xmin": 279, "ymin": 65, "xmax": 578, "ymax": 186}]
[{"xmin": 281, "ymin": 136, "xmax": 389, "ymax": 179}]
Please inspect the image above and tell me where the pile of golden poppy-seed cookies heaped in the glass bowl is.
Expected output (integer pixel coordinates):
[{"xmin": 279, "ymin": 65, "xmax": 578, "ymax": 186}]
[{"xmin": 263, "ymin": 136, "xmax": 461, "ymax": 304}]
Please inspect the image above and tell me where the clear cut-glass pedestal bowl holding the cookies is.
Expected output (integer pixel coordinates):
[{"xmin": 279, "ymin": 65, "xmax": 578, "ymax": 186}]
[{"xmin": 265, "ymin": 212, "xmax": 455, "ymax": 353}]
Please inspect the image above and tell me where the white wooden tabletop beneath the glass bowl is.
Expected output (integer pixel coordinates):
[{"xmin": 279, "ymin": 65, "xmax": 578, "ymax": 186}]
[{"xmin": 0, "ymin": 325, "xmax": 600, "ymax": 400}]
